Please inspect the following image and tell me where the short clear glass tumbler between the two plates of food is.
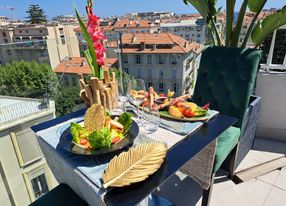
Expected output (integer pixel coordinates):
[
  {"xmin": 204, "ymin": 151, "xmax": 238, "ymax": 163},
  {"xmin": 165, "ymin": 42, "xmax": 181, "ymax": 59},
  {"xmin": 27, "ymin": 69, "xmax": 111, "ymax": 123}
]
[{"xmin": 143, "ymin": 105, "xmax": 161, "ymax": 132}]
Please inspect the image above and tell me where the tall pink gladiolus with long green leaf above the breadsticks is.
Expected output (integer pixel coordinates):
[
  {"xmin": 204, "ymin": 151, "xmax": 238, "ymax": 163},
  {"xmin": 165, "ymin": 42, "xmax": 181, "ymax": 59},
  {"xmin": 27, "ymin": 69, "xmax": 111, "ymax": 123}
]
[{"xmin": 75, "ymin": 0, "xmax": 106, "ymax": 79}]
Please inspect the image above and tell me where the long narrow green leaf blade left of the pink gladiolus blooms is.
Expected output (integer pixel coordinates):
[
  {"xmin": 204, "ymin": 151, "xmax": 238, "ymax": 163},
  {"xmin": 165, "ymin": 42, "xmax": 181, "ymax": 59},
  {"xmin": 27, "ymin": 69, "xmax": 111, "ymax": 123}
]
[{"xmin": 74, "ymin": 6, "xmax": 99, "ymax": 77}]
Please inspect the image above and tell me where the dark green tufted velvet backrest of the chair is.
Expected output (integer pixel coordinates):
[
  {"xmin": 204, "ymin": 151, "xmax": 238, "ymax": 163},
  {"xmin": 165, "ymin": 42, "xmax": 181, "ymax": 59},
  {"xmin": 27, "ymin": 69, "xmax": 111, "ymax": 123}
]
[{"xmin": 193, "ymin": 46, "xmax": 262, "ymax": 128}]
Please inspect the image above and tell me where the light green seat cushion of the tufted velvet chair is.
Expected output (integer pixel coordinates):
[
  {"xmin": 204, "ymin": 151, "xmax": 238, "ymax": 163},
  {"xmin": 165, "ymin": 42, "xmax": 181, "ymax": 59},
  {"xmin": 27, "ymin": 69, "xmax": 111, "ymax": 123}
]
[{"xmin": 214, "ymin": 127, "xmax": 240, "ymax": 172}]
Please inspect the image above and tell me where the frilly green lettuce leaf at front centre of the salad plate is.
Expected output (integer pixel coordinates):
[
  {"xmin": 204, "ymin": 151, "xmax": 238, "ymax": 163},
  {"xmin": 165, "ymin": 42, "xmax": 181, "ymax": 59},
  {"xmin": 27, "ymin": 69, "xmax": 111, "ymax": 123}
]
[{"xmin": 88, "ymin": 127, "xmax": 112, "ymax": 149}]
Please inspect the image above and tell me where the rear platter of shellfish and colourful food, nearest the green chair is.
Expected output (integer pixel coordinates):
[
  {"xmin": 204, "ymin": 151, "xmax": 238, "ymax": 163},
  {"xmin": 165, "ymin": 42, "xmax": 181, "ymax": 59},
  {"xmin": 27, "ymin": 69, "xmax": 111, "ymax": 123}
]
[{"xmin": 131, "ymin": 87, "xmax": 210, "ymax": 122}]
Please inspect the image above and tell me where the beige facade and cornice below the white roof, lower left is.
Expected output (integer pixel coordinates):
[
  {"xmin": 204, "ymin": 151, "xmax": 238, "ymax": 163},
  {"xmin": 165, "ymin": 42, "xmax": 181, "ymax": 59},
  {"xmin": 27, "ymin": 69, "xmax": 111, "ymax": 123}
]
[{"xmin": 0, "ymin": 104, "xmax": 57, "ymax": 206}]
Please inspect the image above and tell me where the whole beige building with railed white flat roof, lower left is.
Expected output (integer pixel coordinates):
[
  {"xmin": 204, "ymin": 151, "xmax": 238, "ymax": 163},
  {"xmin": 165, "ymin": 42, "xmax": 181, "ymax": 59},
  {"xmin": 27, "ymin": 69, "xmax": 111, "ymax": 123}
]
[{"xmin": 0, "ymin": 96, "xmax": 57, "ymax": 206}]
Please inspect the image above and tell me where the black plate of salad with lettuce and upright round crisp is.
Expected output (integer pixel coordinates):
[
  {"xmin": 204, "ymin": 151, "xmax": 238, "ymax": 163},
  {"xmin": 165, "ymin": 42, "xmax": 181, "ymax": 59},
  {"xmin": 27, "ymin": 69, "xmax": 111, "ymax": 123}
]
[{"xmin": 60, "ymin": 104, "xmax": 139, "ymax": 155}]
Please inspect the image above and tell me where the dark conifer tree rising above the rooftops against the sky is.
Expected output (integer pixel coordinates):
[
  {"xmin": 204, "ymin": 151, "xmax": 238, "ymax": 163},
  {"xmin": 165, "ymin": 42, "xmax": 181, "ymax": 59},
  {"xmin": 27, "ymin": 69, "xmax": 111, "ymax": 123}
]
[{"xmin": 26, "ymin": 4, "xmax": 47, "ymax": 24}]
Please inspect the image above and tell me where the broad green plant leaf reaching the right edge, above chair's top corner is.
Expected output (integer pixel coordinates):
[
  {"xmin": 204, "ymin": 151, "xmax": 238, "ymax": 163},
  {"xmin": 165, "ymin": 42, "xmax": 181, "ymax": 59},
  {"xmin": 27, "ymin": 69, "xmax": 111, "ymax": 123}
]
[{"xmin": 251, "ymin": 6, "xmax": 286, "ymax": 46}]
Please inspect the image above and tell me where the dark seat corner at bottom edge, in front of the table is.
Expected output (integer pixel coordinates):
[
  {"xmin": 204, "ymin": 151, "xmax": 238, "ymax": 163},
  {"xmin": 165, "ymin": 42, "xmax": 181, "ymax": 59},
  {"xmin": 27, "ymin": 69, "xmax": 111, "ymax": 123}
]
[{"xmin": 30, "ymin": 184, "xmax": 88, "ymax": 206}]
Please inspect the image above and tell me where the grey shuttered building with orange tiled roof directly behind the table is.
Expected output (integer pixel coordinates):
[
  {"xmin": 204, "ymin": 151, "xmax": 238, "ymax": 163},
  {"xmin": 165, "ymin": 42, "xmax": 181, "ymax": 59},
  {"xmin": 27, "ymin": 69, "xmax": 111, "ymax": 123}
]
[{"xmin": 118, "ymin": 33, "xmax": 203, "ymax": 95}]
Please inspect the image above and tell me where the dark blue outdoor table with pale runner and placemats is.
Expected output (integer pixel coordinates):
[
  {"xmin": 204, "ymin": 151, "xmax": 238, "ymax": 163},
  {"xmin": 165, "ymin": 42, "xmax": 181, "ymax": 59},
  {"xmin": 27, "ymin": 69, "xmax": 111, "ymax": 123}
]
[{"xmin": 32, "ymin": 110, "xmax": 237, "ymax": 206}]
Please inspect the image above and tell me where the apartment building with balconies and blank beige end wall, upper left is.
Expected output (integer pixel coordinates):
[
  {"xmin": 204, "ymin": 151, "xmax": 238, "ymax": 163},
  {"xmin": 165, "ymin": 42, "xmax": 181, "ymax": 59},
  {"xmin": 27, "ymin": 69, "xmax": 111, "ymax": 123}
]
[{"xmin": 0, "ymin": 24, "xmax": 80, "ymax": 68}]
